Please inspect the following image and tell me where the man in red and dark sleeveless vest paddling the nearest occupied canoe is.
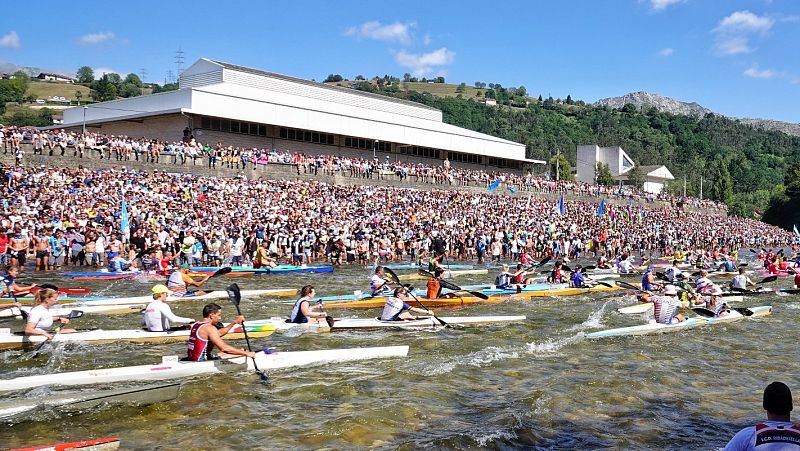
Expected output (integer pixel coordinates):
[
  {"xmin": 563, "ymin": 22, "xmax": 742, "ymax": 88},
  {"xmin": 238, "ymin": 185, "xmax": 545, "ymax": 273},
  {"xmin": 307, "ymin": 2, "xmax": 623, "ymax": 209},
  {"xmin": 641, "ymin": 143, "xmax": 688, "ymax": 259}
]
[{"xmin": 186, "ymin": 302, "xmax": 256, "ymax": 362}]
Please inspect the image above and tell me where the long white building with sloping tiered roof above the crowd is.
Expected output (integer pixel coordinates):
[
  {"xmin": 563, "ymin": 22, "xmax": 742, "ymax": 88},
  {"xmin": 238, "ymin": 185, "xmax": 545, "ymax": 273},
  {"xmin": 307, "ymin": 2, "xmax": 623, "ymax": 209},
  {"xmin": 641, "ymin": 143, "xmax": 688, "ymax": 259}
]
[{"xmin": 59, "ymin": 58, "xmax": 544, "ymax": 171}]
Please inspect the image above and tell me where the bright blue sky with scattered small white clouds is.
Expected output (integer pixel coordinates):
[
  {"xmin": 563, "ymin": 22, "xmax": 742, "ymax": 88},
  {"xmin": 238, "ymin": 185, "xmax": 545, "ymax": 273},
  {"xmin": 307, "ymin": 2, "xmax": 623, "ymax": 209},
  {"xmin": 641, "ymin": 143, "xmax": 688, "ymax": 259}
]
[{"xmin": 0, "ymin": 0, "xmax": 800, "ymax": 122}]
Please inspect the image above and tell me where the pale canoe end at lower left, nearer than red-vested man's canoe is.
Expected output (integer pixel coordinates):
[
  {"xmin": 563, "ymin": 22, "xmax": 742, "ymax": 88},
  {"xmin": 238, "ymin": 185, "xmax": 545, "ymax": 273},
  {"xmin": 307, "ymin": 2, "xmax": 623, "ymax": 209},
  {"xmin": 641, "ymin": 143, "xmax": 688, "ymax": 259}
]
[{"xmin": 0, "ymin": 382, "xmax": 181, "ymax": 420}]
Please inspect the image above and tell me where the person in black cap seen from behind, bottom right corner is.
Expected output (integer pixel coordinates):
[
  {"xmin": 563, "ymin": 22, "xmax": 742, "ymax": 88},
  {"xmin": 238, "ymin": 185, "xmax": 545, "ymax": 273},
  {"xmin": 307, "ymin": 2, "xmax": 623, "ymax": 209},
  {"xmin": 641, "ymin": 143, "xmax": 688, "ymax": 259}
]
[{"xmin": 725, "ymin": 382, "xmax": 800, "ymax": 451}]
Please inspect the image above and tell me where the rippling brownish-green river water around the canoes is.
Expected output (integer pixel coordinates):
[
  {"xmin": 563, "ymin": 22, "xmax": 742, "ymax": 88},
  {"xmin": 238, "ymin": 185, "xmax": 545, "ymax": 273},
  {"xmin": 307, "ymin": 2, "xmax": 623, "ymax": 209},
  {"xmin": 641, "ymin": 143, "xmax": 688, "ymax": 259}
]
[{"xmin": 0, "ymin": 268, "xmax": 800, "ymax": 450}]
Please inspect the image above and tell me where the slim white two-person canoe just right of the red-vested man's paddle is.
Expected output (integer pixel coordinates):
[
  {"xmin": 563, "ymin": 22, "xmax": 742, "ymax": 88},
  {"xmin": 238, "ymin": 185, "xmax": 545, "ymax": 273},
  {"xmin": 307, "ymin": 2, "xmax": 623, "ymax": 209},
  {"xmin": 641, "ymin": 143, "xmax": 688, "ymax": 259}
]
[{"xmin": 266, "ymin": 316, "xmax": 526, "ymax": 332}]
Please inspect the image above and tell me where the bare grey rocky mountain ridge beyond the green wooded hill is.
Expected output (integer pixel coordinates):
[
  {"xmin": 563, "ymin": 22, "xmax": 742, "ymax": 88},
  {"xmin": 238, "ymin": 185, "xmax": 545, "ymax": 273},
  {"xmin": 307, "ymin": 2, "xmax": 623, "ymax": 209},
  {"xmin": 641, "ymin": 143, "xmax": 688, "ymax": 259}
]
[{"xmin": 594, "ymin": 91, "xmax": 800, "ymax": 136}]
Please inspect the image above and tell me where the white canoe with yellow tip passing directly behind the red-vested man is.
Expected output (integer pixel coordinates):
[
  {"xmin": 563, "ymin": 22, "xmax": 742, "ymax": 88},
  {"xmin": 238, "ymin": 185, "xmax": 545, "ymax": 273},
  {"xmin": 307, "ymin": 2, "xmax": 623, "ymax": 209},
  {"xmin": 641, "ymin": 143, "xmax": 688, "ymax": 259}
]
[{"xmin": 0, "ymin": 321, "xmax": 275, "ymax": 349}]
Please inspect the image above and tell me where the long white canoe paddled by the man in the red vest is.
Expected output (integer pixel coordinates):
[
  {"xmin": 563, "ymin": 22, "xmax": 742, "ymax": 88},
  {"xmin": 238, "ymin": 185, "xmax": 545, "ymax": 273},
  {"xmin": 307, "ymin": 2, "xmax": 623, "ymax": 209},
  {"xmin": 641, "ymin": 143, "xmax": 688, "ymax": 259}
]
[{"xmin": 0, "ymin": 346, "xmax": 408, "ymax": 392}]
